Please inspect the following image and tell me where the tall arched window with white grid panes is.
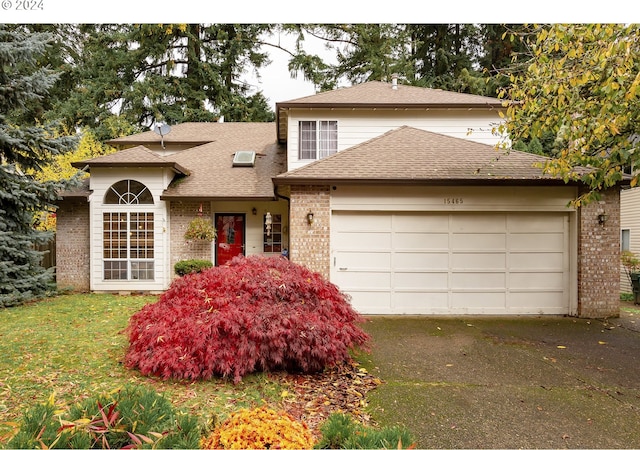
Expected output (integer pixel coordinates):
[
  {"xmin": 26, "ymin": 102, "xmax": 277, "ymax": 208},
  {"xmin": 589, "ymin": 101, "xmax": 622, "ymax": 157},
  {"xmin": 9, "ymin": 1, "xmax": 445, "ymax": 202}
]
[{"xmin": 102, "ymin": 180, "xmax": 154, "ymax": 280}]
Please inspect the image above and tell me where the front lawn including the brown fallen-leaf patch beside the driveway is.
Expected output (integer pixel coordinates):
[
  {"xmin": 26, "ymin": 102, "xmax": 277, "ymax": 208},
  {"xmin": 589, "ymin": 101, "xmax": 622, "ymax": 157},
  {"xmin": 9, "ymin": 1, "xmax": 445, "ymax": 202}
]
[{"xmin": 0, "ymin": 294, "xmax": 380, "ymax": 447}]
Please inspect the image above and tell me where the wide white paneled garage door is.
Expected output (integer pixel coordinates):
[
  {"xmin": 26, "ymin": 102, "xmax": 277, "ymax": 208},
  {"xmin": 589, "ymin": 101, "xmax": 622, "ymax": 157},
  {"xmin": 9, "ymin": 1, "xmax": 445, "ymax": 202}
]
[{"xmin": 331, "ymin": 211, "xmax": 569, "ymax": 314}]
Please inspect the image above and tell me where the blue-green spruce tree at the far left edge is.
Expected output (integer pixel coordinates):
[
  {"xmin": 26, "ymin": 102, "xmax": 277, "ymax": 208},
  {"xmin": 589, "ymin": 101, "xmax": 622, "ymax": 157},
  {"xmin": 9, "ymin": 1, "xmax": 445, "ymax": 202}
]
[{"xmin": 0, "ymin": 24, "xmax": 79, "ymax": 307}]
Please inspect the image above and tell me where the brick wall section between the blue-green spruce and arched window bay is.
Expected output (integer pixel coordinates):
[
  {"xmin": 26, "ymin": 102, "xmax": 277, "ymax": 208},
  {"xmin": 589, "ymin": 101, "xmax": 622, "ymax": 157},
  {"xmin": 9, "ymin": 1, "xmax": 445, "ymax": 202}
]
[{"xmin": 56, "ymin": 198, "xmax": 90, "ymax": 292}]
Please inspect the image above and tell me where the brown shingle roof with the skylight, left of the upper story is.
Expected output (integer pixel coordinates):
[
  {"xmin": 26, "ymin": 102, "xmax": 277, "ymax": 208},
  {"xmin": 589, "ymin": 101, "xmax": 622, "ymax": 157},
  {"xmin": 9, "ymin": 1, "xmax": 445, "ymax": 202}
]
[{"xmin": 74, "ymin": 122, "xmax": 286, "ymax": 200}]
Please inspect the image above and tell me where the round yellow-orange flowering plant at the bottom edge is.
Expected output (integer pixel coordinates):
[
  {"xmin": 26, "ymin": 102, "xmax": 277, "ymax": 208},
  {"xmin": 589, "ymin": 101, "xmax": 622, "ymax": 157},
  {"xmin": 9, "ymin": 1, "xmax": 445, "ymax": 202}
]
[{"xmin": 200, "ymin": 406, "xmax": 314, "ymax": 449}]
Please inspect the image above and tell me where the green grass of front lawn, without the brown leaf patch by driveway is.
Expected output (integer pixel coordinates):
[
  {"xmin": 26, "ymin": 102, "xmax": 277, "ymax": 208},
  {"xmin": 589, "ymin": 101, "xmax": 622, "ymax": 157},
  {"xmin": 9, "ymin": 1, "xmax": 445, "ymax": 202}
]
[{"xmin": 0, "ymin": 294, "xmax": 283, "ymax": 446}]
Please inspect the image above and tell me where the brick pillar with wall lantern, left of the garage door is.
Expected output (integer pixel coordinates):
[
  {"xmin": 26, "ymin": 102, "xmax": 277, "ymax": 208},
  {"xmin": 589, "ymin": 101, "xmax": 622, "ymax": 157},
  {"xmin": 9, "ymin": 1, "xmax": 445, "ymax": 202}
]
[{"xmin": 289, "ymin": 186, "xmax": 331, "ymax": 279}]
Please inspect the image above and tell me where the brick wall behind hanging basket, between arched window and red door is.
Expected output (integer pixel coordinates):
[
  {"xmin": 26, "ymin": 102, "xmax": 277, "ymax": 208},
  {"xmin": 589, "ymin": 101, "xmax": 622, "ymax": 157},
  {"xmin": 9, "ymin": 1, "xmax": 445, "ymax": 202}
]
[{"xmin": 169, "ymin": 201, "xmax": 213, "ymax": 278}]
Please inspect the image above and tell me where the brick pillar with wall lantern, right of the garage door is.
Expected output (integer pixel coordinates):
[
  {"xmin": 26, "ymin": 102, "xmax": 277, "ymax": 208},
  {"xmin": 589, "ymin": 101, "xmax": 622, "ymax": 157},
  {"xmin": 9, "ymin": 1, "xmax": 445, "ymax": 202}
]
[{"xmin": 578, "ymin": 188, "xmax": 620, "ymax": 318}]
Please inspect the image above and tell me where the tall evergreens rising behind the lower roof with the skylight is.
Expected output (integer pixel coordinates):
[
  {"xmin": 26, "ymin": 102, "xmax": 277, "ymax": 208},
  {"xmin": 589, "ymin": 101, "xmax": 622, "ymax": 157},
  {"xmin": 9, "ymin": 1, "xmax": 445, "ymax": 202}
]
[{"xmin": 47, "ymin": 24, "xmax": 275, "ymax": 140}]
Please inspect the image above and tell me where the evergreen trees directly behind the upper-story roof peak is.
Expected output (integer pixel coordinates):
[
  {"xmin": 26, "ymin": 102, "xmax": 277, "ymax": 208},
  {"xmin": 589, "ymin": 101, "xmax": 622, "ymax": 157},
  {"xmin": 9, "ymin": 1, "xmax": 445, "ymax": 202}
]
[{"xmin": 284, "ymin": 24, "xmax": 518, "ymax": 97}]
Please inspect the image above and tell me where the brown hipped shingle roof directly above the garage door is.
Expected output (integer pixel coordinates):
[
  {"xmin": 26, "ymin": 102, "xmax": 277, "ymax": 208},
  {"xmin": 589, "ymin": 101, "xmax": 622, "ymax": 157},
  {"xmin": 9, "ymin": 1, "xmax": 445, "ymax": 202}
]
[{"xmin": 274, "ymin": 126, "xmax": 580, "ymax": 184}]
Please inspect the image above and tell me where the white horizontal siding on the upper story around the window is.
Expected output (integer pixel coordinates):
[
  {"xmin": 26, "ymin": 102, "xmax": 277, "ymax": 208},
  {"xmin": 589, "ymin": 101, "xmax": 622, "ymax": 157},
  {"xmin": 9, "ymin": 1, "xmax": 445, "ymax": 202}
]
[{"xmin": 287, "ymin": 109, "xmax": 500, "ymax": 170}]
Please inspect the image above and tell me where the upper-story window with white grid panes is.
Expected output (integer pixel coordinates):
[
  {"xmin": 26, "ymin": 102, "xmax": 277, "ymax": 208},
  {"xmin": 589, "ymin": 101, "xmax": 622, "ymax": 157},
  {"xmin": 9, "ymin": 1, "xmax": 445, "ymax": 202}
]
[{"xmin": 298, "ymin": 120, "xmax": 338, "ymax": 159}]
